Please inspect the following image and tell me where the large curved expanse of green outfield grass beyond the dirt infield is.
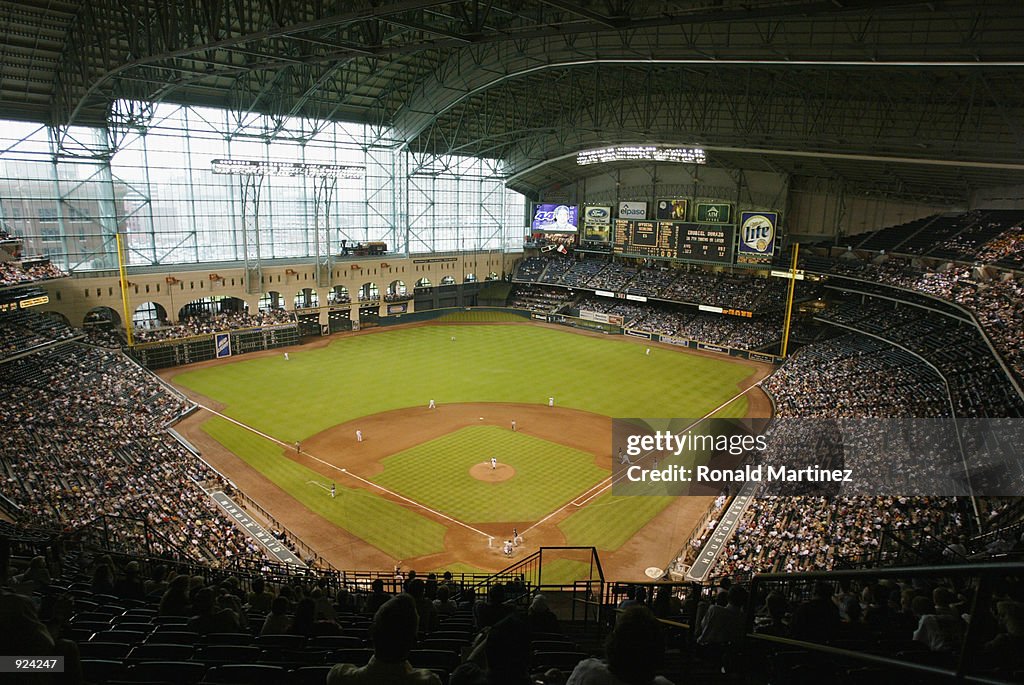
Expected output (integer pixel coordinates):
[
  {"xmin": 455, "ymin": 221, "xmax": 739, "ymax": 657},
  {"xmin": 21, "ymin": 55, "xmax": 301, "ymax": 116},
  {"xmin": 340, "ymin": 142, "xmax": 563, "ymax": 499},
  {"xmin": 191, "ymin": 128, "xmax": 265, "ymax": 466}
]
[{"xmin": 174, "ymin": 325, "xmax": 751, "ymax": 443}]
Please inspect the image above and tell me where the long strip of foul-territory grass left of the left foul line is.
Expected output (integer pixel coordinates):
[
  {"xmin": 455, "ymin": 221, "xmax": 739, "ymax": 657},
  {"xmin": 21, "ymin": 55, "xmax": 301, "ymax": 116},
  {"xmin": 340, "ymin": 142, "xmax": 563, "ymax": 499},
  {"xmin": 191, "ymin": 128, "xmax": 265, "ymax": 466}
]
[{"xmin": 203, "ymin": 418, "xmax": 447, "ymax": 559}]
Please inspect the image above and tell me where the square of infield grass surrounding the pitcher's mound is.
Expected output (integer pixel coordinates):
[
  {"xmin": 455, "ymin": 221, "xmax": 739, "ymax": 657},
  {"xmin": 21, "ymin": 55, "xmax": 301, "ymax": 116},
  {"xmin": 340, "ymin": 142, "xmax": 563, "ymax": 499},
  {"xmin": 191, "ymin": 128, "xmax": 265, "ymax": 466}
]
[{"xmin": 373, "ymin": 426, "xmax": 607, "ymax": 523}]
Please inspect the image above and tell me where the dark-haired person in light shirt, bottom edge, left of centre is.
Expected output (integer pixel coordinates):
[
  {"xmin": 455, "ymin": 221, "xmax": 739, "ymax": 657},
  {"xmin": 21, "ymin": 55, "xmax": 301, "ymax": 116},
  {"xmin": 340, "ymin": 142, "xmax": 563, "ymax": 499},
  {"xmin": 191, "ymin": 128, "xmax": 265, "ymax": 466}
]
[{"xmin": 327, "ymin": 595, "xmax": 441, "ymax": 685}]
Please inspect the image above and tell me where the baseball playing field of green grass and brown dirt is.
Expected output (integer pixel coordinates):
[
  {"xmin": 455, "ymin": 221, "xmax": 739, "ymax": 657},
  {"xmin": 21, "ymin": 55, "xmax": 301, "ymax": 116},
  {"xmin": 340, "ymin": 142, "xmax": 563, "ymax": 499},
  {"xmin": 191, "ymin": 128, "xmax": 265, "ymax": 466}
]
[{"xmin": 163, "ymin": 323, "xmax": 768, "ymax": 579}]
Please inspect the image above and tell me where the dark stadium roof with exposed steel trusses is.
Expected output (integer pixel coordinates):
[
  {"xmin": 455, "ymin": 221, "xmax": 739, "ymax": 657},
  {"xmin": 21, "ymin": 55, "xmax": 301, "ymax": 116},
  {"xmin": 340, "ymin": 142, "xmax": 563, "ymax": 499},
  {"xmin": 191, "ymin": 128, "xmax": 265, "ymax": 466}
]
[{"xmin": 0, "ymin": 0, "xmax": 1024, "ymax": 204}]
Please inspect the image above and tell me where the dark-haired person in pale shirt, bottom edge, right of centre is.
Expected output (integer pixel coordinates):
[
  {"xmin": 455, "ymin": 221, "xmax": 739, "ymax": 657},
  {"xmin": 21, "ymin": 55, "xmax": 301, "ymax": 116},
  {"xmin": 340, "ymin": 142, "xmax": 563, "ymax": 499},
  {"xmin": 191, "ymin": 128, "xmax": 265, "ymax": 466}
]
[{"xmin": 566, "ymin": 606, "xmax": 672, "ymax": 685}]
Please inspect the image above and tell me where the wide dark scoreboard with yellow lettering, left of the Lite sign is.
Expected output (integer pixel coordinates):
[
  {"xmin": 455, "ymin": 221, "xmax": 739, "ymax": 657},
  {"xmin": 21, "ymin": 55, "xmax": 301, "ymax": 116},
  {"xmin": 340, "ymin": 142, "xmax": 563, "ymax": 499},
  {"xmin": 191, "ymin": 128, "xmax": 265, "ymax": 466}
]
[{"xmin": 612, "ymin": 219, "xmax": 736, "ymax": 264}]
